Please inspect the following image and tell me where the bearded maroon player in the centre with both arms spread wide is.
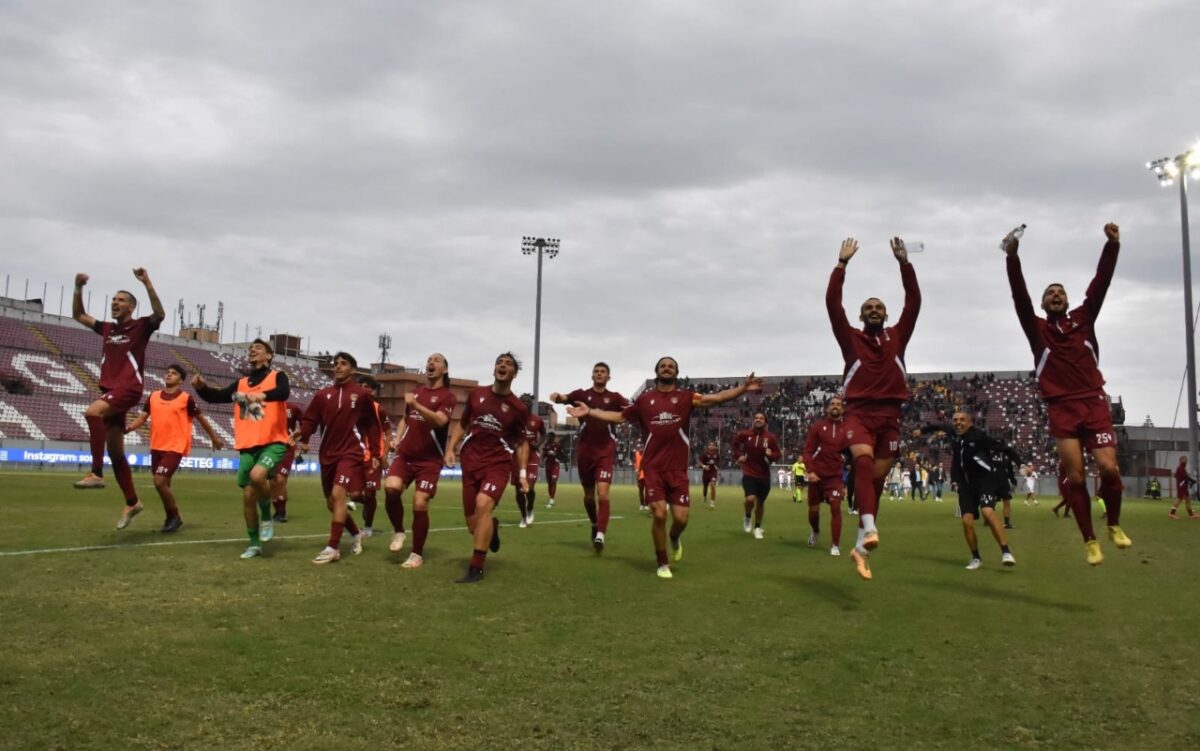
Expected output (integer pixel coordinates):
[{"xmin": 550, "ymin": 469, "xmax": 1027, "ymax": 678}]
[{"xmin": 566, "ymin": 358, "xmax": 762, "ymax": 579}]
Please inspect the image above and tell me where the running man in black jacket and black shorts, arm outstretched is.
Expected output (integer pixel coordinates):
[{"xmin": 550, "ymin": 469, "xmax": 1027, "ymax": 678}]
[{"xmin": 913, "ymin": 411, "xmax": 1021, "ymax": 571}]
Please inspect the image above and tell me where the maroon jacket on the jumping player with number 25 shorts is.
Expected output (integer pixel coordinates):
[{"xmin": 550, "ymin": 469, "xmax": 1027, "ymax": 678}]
[{"xmin": 1008, "ymin": 241, "xmax": 1121, "ymax": 402}]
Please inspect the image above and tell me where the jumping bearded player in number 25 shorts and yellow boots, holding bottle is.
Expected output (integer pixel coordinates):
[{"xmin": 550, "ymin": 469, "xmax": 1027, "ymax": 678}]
[{"xmin": 1003, "ymin": 223, "xmax": 1133, "ymax": 566}]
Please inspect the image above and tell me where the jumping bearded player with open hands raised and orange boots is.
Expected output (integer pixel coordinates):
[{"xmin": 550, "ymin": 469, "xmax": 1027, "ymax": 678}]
[{"xmin": 826, "ymin": 238, "xmax": 920, "ymax": 579}]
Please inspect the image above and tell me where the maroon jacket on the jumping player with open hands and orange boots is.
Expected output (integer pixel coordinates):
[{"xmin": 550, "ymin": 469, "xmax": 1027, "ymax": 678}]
[{"xmin": 826, "ymin": 263, "xmax": 920, "ymax": 411}]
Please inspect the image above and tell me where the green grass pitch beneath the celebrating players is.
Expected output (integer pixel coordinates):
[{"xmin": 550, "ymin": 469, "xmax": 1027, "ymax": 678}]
[{"xmin": 0, "ymin": 473, "xmax": 1200, "ymax": 750}]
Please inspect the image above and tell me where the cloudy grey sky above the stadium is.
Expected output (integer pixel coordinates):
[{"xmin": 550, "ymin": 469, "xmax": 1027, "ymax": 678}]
[{"xmin": 0, "ymin": 0, "xmax": 1200, "ymax": 425}]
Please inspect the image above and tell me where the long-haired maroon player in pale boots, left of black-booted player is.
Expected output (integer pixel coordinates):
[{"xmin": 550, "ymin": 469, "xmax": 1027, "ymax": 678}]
[{"xmin": 384, "ymin": 352, "xmax": 458, "ymax": 569}]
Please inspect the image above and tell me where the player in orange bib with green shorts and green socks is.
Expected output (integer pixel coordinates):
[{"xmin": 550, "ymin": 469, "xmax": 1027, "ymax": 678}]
[{"xmin": 192, "ymin": 340, "xmax": 292, "ymax": 558}]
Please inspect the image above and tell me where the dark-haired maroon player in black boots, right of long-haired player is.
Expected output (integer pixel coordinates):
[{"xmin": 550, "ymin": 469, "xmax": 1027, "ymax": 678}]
[{"xmin": 444, "ymin": 352, "xmax": 529, "ymax": 584}]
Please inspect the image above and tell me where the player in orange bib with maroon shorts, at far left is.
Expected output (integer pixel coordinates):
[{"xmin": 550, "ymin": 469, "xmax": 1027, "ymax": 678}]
[{"xmin": 125, "ymin": 365, "xmax": 224, "ymax": 533}]
